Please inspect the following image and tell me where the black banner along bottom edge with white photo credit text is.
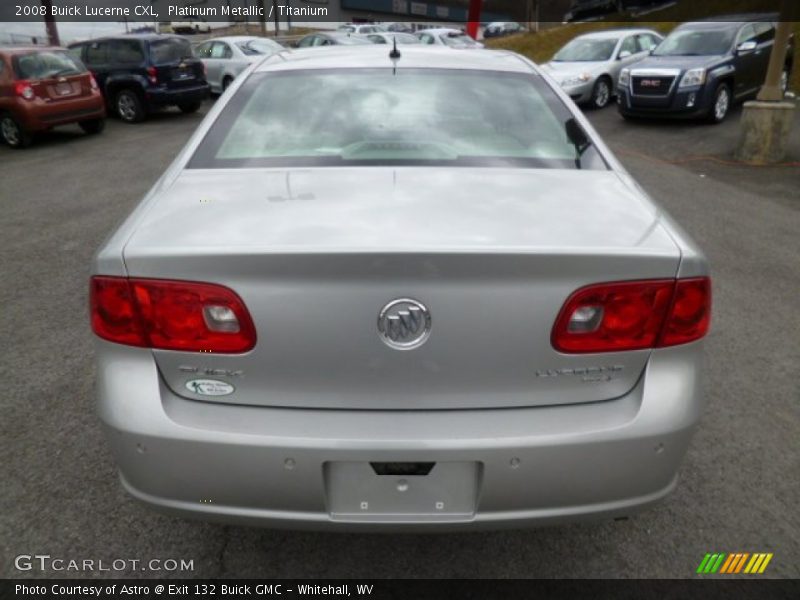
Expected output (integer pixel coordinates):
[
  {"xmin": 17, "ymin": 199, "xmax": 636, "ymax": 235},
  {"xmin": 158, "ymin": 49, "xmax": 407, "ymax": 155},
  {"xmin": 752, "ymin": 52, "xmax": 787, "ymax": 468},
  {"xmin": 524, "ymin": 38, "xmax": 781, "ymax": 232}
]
[{"xmin": 0, "ymin": 578, "xmax": 800, "ymax": 600}]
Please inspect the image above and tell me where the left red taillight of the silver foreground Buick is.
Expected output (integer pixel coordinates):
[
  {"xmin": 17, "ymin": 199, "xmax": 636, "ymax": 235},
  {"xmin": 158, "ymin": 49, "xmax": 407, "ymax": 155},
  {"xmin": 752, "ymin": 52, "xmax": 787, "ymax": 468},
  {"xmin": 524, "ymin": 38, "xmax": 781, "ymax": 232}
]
[{"xmin": 91, "ymin": 276, "xmax": 256, "ymax": 353}]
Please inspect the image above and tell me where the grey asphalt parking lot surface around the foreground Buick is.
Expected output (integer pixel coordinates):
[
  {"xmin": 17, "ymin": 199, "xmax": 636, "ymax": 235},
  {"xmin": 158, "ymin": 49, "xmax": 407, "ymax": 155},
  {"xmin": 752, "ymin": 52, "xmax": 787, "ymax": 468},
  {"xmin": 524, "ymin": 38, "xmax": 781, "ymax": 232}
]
[{"xmin": 0, "ymin": 101, "xmax": 800, "ymax": 578}]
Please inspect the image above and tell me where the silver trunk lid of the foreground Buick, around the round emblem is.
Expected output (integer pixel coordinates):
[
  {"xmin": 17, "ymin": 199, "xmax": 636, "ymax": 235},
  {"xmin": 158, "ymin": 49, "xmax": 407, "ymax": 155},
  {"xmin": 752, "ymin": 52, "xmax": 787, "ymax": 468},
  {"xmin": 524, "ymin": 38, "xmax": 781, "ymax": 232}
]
[{"xmin": 125, "ymin": 168, "xmax": 680, "ymax": 409}]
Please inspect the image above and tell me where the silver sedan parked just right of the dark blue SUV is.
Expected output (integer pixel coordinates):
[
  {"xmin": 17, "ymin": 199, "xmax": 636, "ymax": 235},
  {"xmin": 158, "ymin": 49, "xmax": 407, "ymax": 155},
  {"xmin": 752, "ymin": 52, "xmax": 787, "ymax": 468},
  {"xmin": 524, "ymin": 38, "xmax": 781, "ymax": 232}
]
[{"xmin": 194, "ymin": 35, "xmax": 285, "ymax": 93}]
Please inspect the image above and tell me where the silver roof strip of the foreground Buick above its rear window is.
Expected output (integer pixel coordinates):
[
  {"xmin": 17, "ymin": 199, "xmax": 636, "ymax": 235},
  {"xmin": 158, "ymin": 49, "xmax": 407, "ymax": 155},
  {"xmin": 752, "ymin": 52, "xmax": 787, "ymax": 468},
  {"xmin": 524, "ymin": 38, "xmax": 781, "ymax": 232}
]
[{"xmin": 256, "ymin": 44, "xmax": 534, "ymax": 73}]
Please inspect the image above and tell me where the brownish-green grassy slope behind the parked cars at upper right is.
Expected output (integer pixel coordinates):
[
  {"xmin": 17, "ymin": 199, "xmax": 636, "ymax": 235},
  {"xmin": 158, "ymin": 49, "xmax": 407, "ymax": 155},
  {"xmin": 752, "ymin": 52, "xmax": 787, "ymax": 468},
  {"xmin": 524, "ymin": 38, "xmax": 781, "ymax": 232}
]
[{"xmin": 487, "ymin": 9, "xmax": 800, "ymax": 93}]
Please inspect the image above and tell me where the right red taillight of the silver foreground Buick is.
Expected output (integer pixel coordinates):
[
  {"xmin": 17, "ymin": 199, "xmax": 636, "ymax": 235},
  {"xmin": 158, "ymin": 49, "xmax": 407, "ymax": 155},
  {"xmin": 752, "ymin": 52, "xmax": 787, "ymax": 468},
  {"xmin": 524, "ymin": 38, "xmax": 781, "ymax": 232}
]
[{"xmin": 551, "ymin": 277, "xmax": 711, "ymax": 354}]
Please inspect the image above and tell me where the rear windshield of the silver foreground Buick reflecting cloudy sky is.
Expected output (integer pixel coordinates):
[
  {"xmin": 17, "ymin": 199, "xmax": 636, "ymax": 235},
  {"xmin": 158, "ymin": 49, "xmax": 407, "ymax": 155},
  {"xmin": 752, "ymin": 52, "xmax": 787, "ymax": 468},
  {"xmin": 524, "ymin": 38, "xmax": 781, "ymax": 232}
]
[{"xmin": 189, "ymin": 69, "xmax": 606, "ymax": 168}]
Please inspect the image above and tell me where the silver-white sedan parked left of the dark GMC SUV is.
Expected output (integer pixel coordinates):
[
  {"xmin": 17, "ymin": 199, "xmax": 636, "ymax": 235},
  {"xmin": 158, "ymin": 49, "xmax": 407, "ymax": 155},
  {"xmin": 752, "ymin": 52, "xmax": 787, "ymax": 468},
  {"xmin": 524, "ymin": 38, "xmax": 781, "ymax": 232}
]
[{"xmin": 544, "ymin": 29, "xmax": 664, "ymax": 108}]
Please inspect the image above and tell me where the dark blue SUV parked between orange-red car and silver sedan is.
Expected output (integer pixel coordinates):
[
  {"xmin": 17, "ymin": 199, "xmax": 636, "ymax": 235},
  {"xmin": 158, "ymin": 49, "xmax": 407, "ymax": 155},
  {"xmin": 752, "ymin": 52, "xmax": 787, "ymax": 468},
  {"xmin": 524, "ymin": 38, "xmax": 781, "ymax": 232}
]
[{"xmin": 69, "ymin": 34, "xmax": 208, "ymax": 123}]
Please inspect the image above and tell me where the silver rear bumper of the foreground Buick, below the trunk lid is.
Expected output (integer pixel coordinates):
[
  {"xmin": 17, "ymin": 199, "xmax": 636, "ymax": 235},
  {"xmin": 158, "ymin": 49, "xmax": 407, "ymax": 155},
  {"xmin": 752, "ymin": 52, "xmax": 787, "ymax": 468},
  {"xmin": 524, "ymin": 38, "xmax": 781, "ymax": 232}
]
[{"xmin": 98, "ymin": 342, "xmax": 702, "ymax": 530}]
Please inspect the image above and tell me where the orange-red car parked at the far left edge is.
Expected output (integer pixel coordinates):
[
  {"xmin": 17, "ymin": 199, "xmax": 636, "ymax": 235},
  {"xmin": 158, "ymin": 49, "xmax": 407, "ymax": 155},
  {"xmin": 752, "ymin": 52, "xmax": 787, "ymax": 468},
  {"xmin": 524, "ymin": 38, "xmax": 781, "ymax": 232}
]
[{"xmin": 0, "ymin": 46, "xmax": 105, "ymax": 148}]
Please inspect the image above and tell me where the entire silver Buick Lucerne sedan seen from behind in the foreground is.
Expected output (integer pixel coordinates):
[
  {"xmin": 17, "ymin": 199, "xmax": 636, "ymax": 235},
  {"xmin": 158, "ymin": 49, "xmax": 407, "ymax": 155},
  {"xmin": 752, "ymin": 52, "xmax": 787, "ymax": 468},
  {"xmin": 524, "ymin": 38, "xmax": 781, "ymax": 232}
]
[{"xmin": 91, "ymin": 46, "xmax": 711, "ymax": 530}]
